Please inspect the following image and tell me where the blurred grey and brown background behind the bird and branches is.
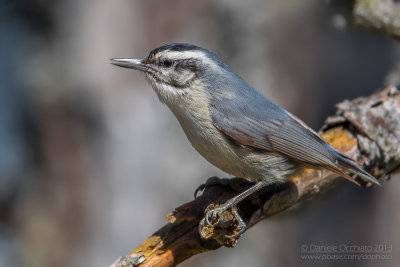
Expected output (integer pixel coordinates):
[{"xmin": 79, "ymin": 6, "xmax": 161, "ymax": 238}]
[{"xmin": 0, "ymin": 0, "xmax": 400, "ymax": 267}]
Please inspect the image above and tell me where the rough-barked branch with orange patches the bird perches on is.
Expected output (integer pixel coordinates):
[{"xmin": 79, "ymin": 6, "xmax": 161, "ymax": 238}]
[{"xmin": 111, "ymin": 87, "xmax": 400, "ymax": 267}]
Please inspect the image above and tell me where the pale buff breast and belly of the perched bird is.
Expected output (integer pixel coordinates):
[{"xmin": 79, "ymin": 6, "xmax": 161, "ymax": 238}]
[{"xmin": 170, "ymin": 92, "xmax": 295, "ymax": 183}]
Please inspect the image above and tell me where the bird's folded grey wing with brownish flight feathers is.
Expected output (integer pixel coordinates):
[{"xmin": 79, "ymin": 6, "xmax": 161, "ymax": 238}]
[{"xmin": 211, "ymin": 98, "xmax": 340, "ymax": 171}]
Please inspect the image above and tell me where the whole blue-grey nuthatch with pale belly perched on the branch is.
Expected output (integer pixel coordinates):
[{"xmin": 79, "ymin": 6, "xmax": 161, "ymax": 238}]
[{"xmin": 111, "ymin": 44, "xmax": 379, "ymax": 239}]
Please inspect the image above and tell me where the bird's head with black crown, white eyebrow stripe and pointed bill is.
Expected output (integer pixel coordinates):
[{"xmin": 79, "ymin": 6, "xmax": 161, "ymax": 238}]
[{"xmin": 111, "ymin": 43, "xmax": 228, "ymax": 104}]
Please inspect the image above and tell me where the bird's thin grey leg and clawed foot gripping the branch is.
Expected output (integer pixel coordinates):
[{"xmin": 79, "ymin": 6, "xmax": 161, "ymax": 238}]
[{"xmin": 204, "ymin": 181, "xmax": 266, "ymax": 238}]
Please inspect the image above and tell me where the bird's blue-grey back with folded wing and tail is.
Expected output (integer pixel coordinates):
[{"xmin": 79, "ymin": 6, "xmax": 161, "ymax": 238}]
[{"xmin": 208, "ymin": 72, "xmax": 379, "ymax": 184}]
